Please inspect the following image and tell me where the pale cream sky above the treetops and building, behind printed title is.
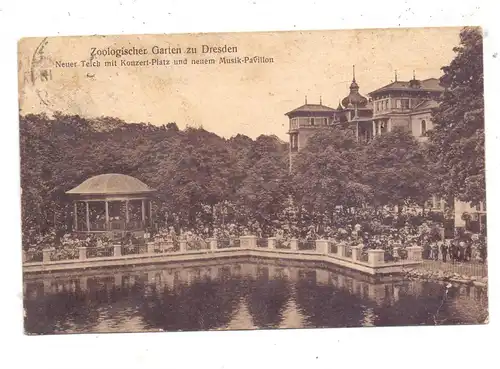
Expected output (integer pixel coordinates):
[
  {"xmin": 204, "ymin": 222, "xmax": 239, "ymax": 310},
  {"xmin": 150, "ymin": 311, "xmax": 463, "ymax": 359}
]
[{"xmin": 18, "ymin": 27, "xmax": 460, "ymax": 140}]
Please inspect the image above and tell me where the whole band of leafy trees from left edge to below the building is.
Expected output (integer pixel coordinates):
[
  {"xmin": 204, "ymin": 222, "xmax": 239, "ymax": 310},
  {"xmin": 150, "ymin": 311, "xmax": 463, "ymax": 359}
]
[{"xmin": 20, "ymin": 115, "xmax": 432, "ymax": 240}]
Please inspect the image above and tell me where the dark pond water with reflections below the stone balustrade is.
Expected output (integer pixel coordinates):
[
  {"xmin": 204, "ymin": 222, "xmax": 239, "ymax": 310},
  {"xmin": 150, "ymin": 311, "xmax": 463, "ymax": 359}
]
[{"xmin": 24, "ymin": 262, "xmax": 487, "ymax": 334}]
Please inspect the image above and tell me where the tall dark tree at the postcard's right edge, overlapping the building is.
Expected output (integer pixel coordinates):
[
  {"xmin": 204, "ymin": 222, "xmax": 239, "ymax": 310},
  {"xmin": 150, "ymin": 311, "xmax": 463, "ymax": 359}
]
[{"xmin": 428, "ymin": 27, "xmax": 486, "ymax": 204}]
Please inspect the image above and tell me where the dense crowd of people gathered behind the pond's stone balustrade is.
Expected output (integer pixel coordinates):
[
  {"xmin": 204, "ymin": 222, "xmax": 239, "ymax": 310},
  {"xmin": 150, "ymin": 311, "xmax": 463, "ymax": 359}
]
[{"xmin": 24, "ymin": 208, "xmax": 487, "ymax": 262}]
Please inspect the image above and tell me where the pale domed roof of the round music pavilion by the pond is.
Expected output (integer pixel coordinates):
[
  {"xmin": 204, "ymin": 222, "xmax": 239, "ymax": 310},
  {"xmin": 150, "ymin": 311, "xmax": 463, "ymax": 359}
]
[{"xmin": 66, "ymin": 173, "xmax": 155, "ymax": 195}]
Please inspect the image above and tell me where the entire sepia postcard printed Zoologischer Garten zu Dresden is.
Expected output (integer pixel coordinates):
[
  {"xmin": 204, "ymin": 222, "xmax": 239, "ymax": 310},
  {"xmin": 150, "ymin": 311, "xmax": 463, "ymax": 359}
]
[{"xmin": 18, "ymin": 27, "xmax": 488, "ymax": 334}]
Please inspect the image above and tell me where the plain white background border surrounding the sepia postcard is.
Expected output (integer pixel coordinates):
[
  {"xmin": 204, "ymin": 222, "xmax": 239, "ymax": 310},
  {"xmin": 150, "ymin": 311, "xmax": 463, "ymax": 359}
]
[{"xmin": 0, "ymin": 0, "xmax": 500, "ymax": 368}]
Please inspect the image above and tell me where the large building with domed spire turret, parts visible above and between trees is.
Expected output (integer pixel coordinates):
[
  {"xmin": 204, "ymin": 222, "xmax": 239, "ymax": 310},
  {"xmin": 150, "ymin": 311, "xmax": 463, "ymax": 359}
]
[{"xmin": 285, "ymin": 67, "xmax": 486, "ymax": 231}]
